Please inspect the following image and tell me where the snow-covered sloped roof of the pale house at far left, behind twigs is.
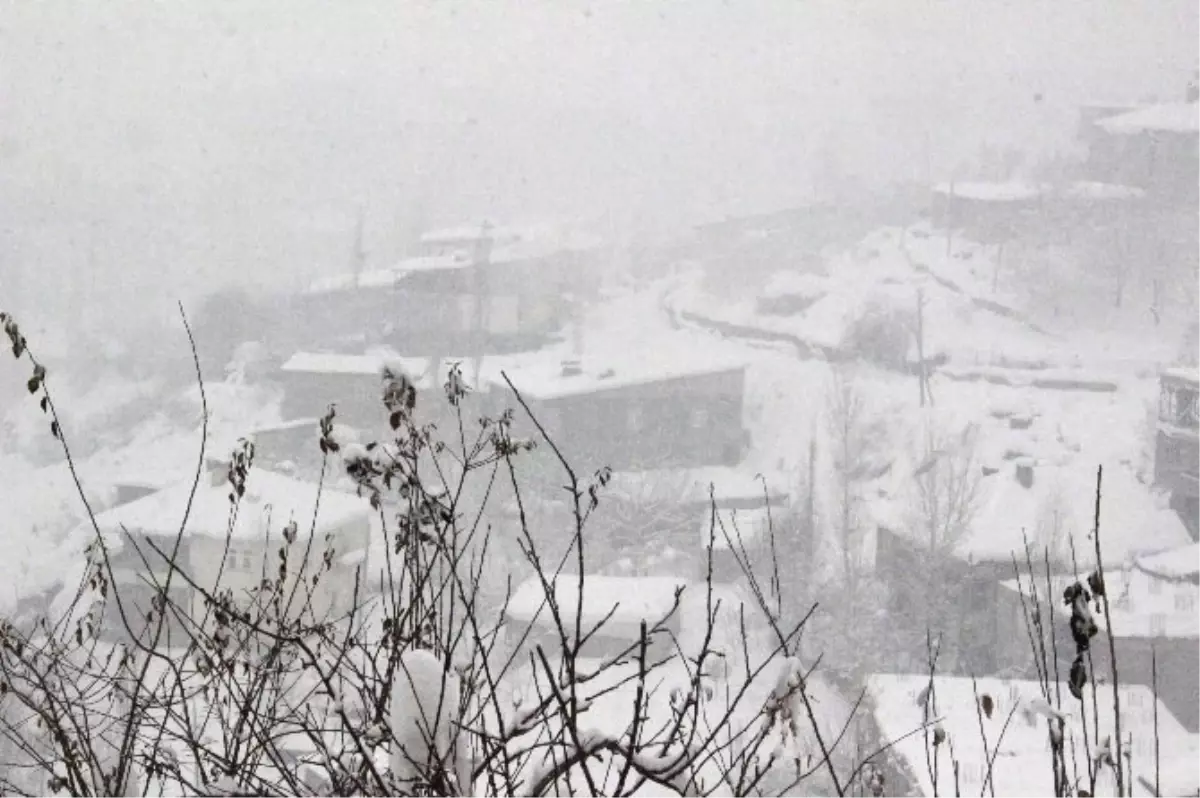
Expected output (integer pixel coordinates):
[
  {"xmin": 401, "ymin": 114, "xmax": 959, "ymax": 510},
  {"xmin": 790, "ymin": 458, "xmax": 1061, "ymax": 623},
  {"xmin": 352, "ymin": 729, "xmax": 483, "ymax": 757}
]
[{"xmin": 84, "ymin": 468, "xmax": 371, "ymax": 540}]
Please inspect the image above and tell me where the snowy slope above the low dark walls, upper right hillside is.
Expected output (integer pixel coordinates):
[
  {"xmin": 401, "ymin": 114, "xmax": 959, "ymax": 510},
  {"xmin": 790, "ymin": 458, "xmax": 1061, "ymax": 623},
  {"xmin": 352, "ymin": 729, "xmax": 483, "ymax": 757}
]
[{"xmin": 672, "ymin": 220, "xmax": 1189, "ymax": 373}]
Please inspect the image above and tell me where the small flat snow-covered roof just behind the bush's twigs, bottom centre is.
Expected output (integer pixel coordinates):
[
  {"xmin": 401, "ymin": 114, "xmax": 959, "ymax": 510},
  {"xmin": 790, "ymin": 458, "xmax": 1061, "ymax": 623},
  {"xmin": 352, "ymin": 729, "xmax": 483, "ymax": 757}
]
[{"xmin": 506, "ymin": 574, "xmax": 703, "ymax": 634}]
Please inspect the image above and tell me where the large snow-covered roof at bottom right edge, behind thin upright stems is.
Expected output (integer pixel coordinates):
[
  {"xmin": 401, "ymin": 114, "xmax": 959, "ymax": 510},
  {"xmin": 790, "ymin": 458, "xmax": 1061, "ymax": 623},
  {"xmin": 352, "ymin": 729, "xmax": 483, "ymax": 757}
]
[{"xmin": 866, "ymin": 674, "xmax": 1198, "ymax": 798}]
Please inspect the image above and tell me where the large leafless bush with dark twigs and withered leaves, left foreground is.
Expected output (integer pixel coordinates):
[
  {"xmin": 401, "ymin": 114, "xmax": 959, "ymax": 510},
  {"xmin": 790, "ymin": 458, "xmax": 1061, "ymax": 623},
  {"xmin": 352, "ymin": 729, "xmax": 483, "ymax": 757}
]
[{"xmin": 0, "ymin": 316, "xmax": 916, "ymax": 798}]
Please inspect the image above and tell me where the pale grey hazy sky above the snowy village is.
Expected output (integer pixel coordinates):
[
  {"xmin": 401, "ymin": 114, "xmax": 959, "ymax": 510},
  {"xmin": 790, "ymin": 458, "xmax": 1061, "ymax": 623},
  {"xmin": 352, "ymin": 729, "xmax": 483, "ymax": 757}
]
[{"xmin": 0, "ymin": 0, "xmax": 1200, "ymax": 328}]
